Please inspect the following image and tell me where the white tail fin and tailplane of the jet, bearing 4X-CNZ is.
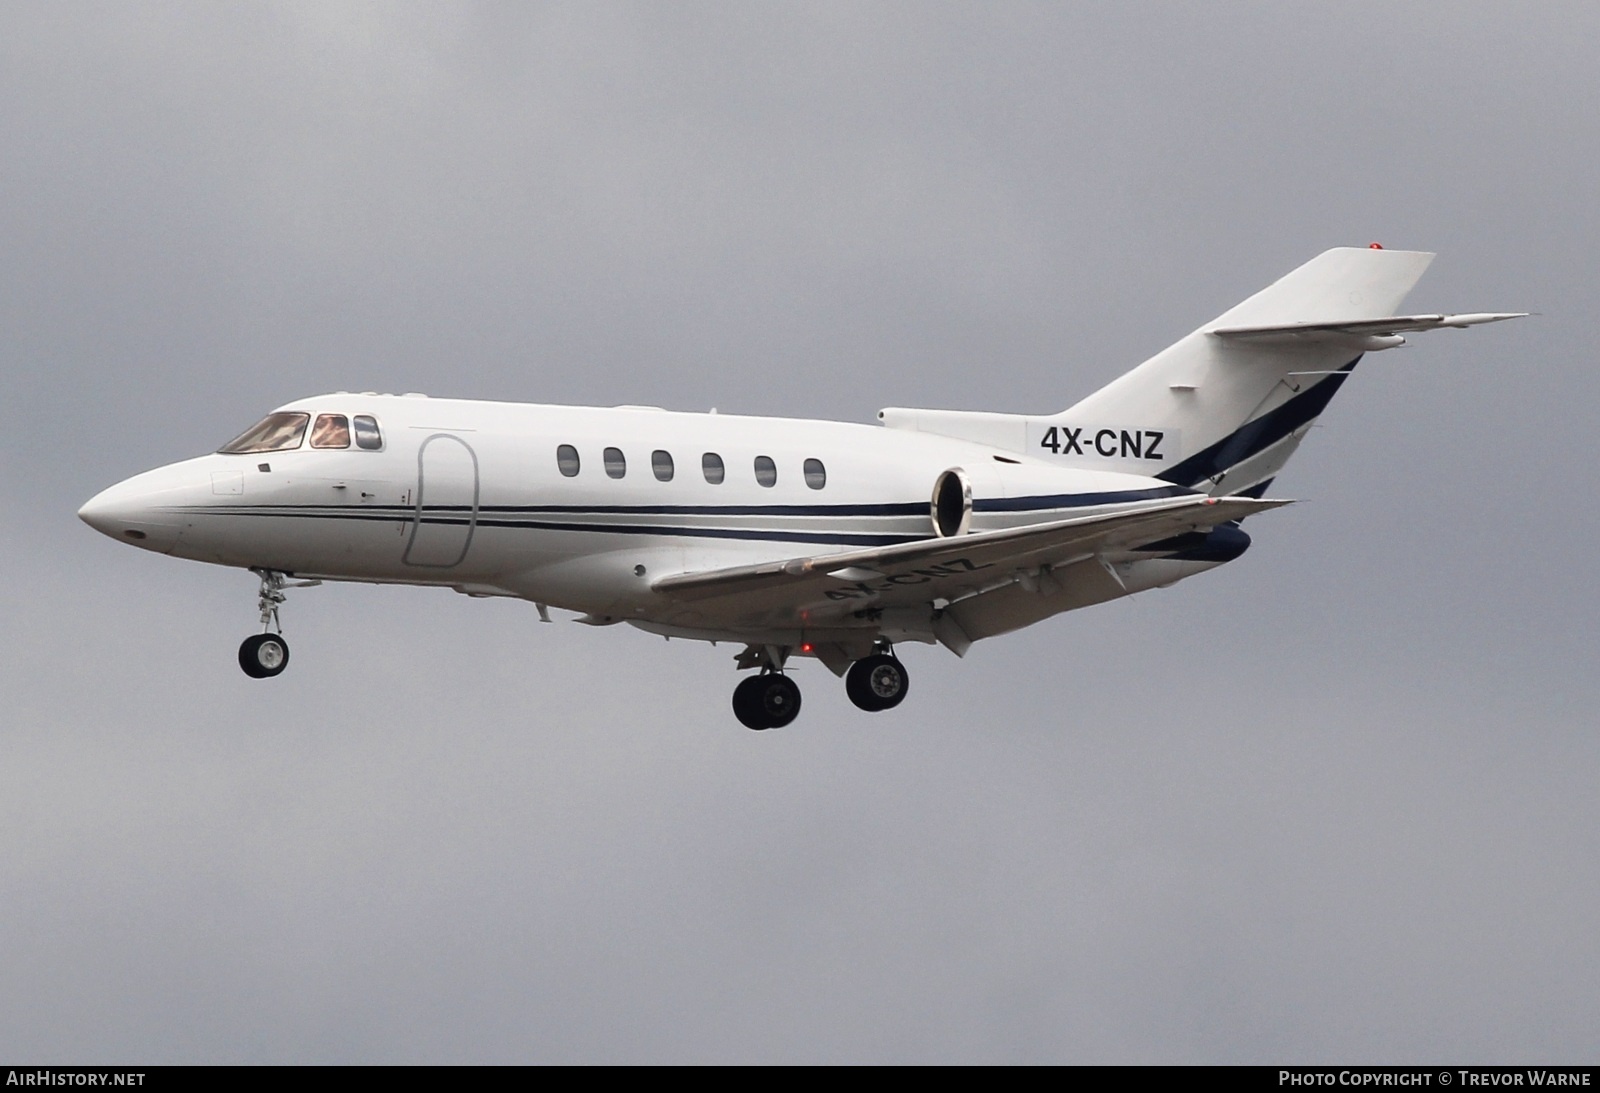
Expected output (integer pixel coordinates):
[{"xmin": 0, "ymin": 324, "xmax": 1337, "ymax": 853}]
[{"xmin": 878, "ymin": 246, "xmax": 1525, "ymax": 498}]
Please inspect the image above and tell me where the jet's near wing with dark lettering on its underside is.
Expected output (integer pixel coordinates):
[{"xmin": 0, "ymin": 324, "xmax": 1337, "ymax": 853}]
[{"xmin": 651, "ymin": 496, "xmax": 1291, "ymax": 608}]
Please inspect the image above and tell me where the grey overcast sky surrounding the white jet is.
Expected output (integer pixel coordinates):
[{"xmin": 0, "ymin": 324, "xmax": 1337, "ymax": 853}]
[{"xmin": 0, "ymin": 3, "xmax": 1600, "ymax": 1063}]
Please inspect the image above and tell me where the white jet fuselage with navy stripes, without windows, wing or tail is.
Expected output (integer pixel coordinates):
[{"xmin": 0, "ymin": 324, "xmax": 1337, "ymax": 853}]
[{"xmin": 83, "ymin": 394, "xmax": 1216, "ymax": 640}]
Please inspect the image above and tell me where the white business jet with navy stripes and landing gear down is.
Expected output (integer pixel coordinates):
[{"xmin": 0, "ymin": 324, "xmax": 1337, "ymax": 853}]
[{"xmin": 78, "ymin": 245, "xmax": 1518, "ymax": 728}]
